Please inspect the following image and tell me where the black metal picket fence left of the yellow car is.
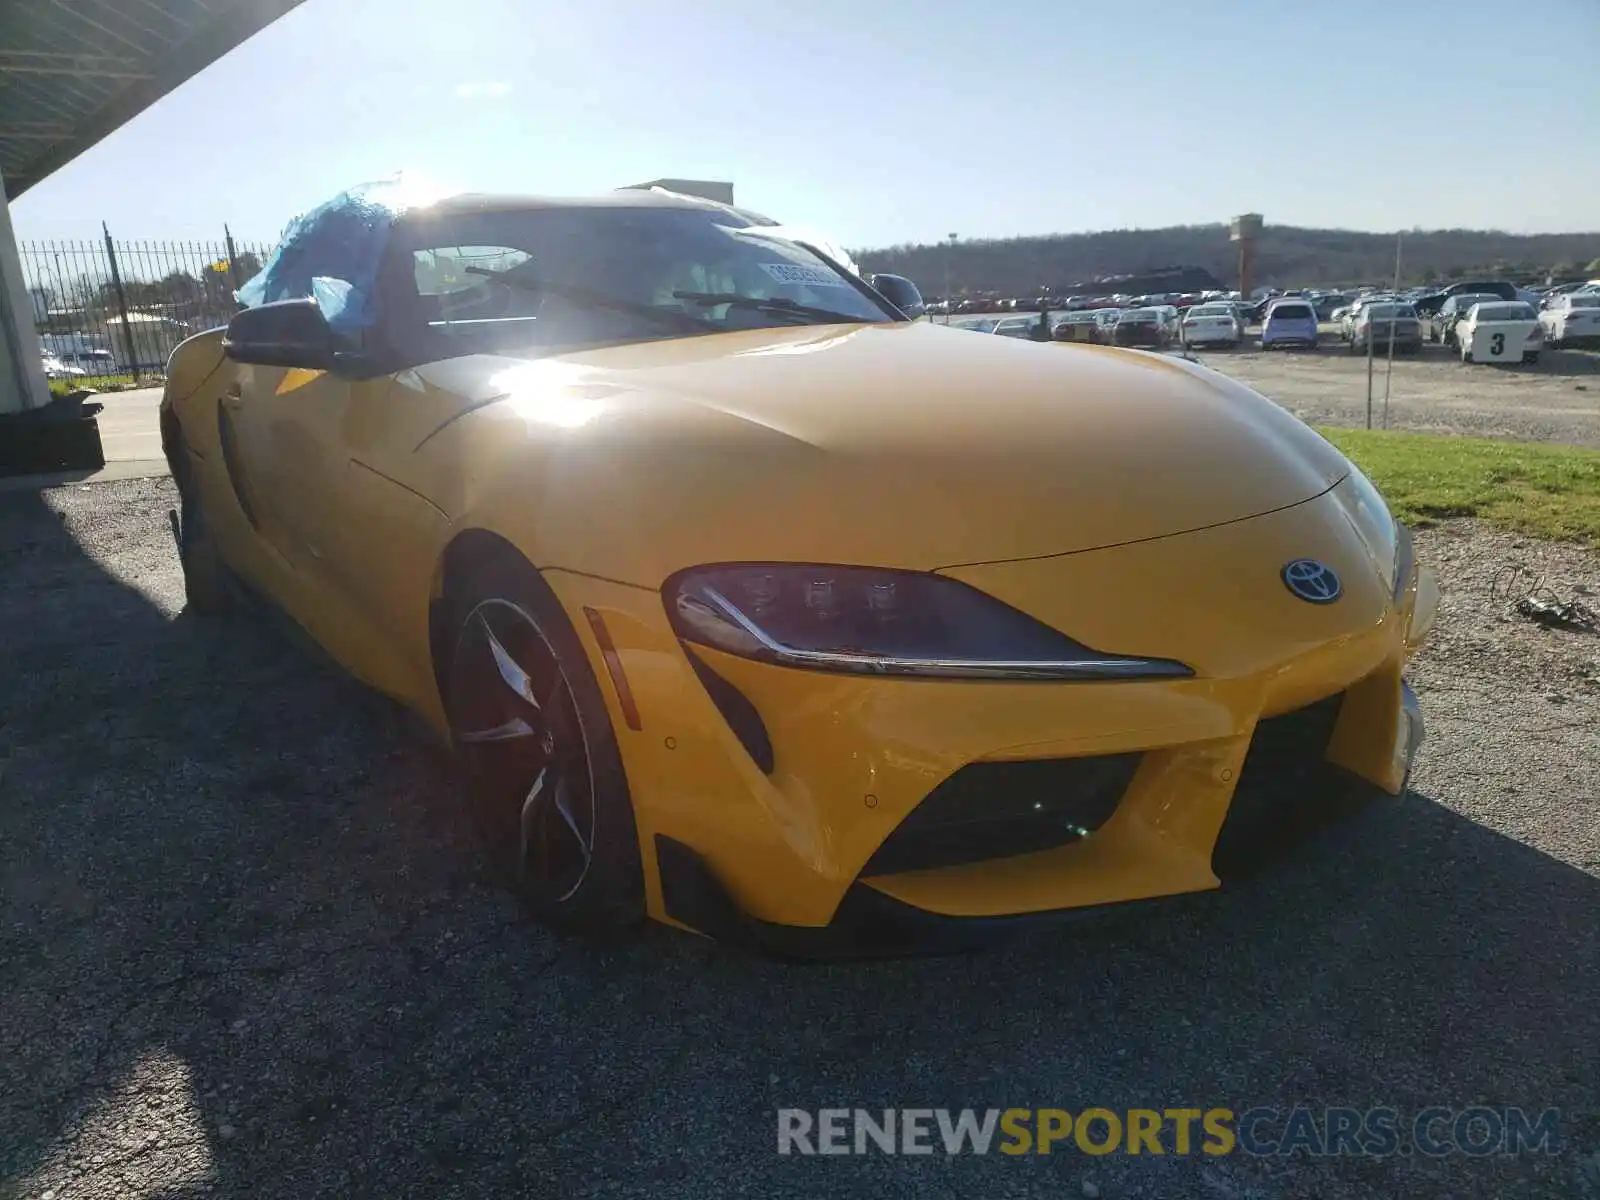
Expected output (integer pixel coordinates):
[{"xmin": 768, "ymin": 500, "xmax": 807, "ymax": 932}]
[{"xmin": 18, "ymin": 227, "xmax": 272, "ymax": 390}]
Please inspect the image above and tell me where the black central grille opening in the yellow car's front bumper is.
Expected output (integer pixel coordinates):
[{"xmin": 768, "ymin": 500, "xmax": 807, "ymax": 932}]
[{"xmin": 861, "ymin": 754, "xmax": 1141, "ymax": 875}]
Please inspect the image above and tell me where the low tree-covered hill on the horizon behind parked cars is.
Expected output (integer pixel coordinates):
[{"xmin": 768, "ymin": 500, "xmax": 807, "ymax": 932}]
[{"xmin": 851, "ymin": 224, "xmax": 1600, "ymax": 296}]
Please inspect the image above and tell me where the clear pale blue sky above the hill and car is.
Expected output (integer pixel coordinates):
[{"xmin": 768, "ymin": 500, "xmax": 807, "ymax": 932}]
[{"xmin": 13, "ymin": 0, "xmax": 1600, "ymax": 246}]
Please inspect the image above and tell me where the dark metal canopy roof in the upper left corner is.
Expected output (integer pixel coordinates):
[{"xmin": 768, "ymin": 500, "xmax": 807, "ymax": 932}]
[{"xmin": 0, "ymin": 0, "xmax": 301, "ymax": 200}]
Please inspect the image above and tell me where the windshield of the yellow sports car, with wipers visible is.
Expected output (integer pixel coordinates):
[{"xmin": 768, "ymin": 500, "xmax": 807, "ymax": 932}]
[{"xmin": 386, "ymin": 205, "xmax": 894, "ymax": 358}]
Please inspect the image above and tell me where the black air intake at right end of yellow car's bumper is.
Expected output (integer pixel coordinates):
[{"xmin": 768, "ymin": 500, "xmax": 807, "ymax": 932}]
[{"xmin": 1211, "ymin": 693, "xmax": 1344, "ymax": 875}]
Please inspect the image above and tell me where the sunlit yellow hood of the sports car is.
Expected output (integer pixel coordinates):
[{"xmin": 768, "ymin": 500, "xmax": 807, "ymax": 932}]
[{"xmin": 419, "ymin": 322, "xmax": 1349, "ymax": 582}]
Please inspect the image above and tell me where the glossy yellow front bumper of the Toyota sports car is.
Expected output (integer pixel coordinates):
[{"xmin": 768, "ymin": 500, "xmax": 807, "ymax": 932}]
[{"xmin": 547, "ymin": 490, "xmax": 1437, "ymax": 955}]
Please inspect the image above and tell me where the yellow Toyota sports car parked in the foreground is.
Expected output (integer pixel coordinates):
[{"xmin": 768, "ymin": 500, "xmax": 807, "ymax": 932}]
[{"xmin": 162, "ymin": 190, "xmax": 1438, "ymax": 955}]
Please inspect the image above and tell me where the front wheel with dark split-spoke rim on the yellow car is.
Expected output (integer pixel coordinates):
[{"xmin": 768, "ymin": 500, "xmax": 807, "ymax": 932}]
[{"xmin": 440, "ymin": 554, "xmax": 645, "ymax": 936}]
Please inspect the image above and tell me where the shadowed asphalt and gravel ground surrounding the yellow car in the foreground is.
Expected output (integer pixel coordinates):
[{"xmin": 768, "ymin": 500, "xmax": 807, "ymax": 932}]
[{"xmin": 0, "ymin": 480, "xmax": 1600, "ymax": 1200}]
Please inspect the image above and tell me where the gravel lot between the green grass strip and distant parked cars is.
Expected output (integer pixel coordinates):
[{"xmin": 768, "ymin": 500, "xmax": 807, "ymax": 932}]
[{"xmin": 1198, "ymin": 334, "xmax": 1600, "ymax": 446}]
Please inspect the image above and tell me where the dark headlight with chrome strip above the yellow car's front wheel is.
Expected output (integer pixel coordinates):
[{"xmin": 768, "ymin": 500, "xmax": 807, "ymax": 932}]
[{"xmin": 666, "ymin": 563, "xmax": 1194, "ymax": 680}]
